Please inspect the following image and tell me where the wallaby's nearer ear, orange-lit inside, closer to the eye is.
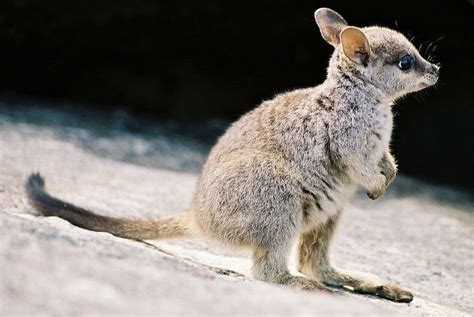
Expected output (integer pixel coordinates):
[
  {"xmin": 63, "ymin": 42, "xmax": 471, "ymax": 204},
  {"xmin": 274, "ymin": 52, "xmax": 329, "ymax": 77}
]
[{"xmin": 340, "ymin": 26, "xmax": 370, "ymax": 65}]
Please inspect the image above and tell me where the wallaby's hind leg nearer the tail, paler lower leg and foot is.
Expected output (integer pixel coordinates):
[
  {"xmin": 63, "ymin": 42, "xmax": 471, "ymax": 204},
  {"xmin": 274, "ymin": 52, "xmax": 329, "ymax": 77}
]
[{"xmin": 252, "ymin": 242, "xmax": 329, "ymax": 292}]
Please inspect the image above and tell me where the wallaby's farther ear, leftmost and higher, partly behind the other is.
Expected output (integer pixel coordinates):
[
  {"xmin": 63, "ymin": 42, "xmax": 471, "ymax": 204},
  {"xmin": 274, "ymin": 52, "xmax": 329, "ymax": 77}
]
[{"xmin": 314, "ymin": 8, "xmax": 347, "ymax": 46}]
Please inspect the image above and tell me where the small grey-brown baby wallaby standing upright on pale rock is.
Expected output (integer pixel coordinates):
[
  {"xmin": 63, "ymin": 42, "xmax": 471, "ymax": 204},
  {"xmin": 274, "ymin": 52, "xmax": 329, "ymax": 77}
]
[{"xmin": 26, "ymin": 8, "xmax": 439, "ymax": 302}]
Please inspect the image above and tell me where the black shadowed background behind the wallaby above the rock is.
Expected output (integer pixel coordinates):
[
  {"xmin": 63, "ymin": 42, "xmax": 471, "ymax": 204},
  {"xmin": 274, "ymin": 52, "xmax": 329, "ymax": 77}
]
[{"xmin": 0, "ymin": 0, "xmax": 474, "ymax": 190}]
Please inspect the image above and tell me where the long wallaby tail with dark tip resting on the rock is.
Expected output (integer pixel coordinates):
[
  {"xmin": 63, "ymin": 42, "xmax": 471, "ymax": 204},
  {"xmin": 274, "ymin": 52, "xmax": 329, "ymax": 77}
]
[{"xmin": 26, "ymin": 173, "xmax": 191, "ymax": 240}]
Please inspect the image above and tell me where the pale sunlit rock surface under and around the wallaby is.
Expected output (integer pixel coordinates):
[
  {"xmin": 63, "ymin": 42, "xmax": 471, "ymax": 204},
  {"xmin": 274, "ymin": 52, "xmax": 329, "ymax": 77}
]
[{"xmin": 0, "ymin": 104, "xmax": 474, "ymax": 316}]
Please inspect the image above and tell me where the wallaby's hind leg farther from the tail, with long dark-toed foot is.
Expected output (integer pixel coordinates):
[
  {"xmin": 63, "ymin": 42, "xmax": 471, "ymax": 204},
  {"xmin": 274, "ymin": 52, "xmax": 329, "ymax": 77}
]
[{"xmin": 298, "ymin": 216, "xmax": 413, "ymax": 302}]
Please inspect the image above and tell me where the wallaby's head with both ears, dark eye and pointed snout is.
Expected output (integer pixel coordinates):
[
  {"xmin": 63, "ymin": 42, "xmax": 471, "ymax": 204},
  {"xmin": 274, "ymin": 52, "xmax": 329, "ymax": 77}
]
[{"xmin": 314, "ymin": 8, "xmax": 439, "ymax": 100}]
